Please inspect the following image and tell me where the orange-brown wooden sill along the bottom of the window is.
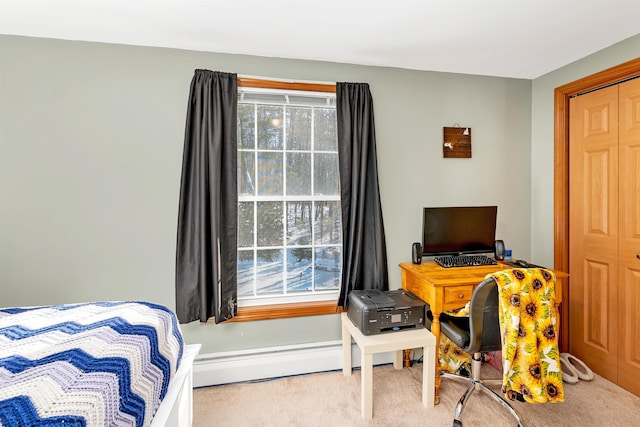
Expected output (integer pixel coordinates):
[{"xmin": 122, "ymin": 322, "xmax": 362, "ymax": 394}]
[{"xmin": 225, "ymin": 301, "xmax": 342, "ymax": 323}]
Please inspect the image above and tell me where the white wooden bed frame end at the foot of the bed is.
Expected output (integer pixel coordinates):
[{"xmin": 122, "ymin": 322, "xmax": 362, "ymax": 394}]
[{"xmin": 150, "ymin": 344, "xmax": 200, "ymax": 427}]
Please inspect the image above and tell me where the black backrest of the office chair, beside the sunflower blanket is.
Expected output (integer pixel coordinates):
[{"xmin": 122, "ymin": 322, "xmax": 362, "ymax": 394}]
[{"xmin": 462, "ymin": 277, "xmax": 502, "ymax": 354}]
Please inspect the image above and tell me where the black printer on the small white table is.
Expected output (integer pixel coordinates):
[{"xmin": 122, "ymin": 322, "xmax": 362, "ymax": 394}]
[{"xmin": 347, "ymin": 289, "xmax": 425, "ymax": 335}]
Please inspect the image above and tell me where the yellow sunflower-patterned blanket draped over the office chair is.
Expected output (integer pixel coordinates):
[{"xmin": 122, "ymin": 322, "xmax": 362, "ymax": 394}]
[{"xmin": 487, "ymin": 268, "xmax": 564, "ymax": 403}]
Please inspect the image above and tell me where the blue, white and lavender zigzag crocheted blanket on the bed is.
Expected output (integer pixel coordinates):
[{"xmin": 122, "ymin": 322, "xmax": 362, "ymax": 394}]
[{"xmin": 0, "ymin": 302, "xmax": 184, "ymax": 427}]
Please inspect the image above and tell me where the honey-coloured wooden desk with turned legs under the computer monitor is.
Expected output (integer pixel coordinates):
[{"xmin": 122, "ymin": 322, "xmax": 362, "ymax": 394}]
[{"xmin": 400, "ymin": 261, "xmax": 569, "ymax": 405}]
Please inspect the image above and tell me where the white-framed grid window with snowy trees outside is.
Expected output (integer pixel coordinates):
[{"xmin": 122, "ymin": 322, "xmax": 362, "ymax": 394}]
[{"xmin": 238, "ymin": 79, "xmax": 342, "ymax": 307}]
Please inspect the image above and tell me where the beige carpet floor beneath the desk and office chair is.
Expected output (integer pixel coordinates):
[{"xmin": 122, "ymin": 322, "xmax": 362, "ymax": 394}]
[{"xmin": 193, "ymin": 364, "xmax": 640, "ymax": 427}]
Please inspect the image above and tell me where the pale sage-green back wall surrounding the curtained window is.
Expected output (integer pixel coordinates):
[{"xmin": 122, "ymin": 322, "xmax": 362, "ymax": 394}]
[{"xmin": 0, "ymin": 36, "xmax": 532, "ymax": 353}]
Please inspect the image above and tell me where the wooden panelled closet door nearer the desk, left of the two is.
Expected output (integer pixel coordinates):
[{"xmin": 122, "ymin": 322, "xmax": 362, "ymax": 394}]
[{"xmin": 569, "ymin": 86, "xmax": 619, "ymax": 383}]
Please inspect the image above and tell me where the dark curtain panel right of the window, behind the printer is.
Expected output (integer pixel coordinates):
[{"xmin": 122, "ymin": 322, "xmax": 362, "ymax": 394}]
[{"xmin": 336, "ymin": 83, "xmax": 389, "ymax": 308}]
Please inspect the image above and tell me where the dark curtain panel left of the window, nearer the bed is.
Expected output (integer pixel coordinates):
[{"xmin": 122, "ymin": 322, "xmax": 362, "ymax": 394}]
[{"xmin": 176, "ymin": 70, "xmax": 238, "ymax": 323}]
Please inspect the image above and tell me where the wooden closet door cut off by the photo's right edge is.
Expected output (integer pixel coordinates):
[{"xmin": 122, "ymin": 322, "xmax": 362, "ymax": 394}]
[{"xmin": 618, "ymin": 79, "xmax": 640, "ymax": 396}]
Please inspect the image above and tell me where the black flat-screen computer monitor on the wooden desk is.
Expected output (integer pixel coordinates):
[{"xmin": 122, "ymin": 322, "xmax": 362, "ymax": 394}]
[{"xmin": 422, "ymin": 206, "xmax": 498, "ymax": 256}]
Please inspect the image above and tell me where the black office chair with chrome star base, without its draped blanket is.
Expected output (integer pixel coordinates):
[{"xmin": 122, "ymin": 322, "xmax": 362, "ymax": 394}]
[{"xmin": 426, "ymin": 277, "xmax": 524, "ymax": 427}]
